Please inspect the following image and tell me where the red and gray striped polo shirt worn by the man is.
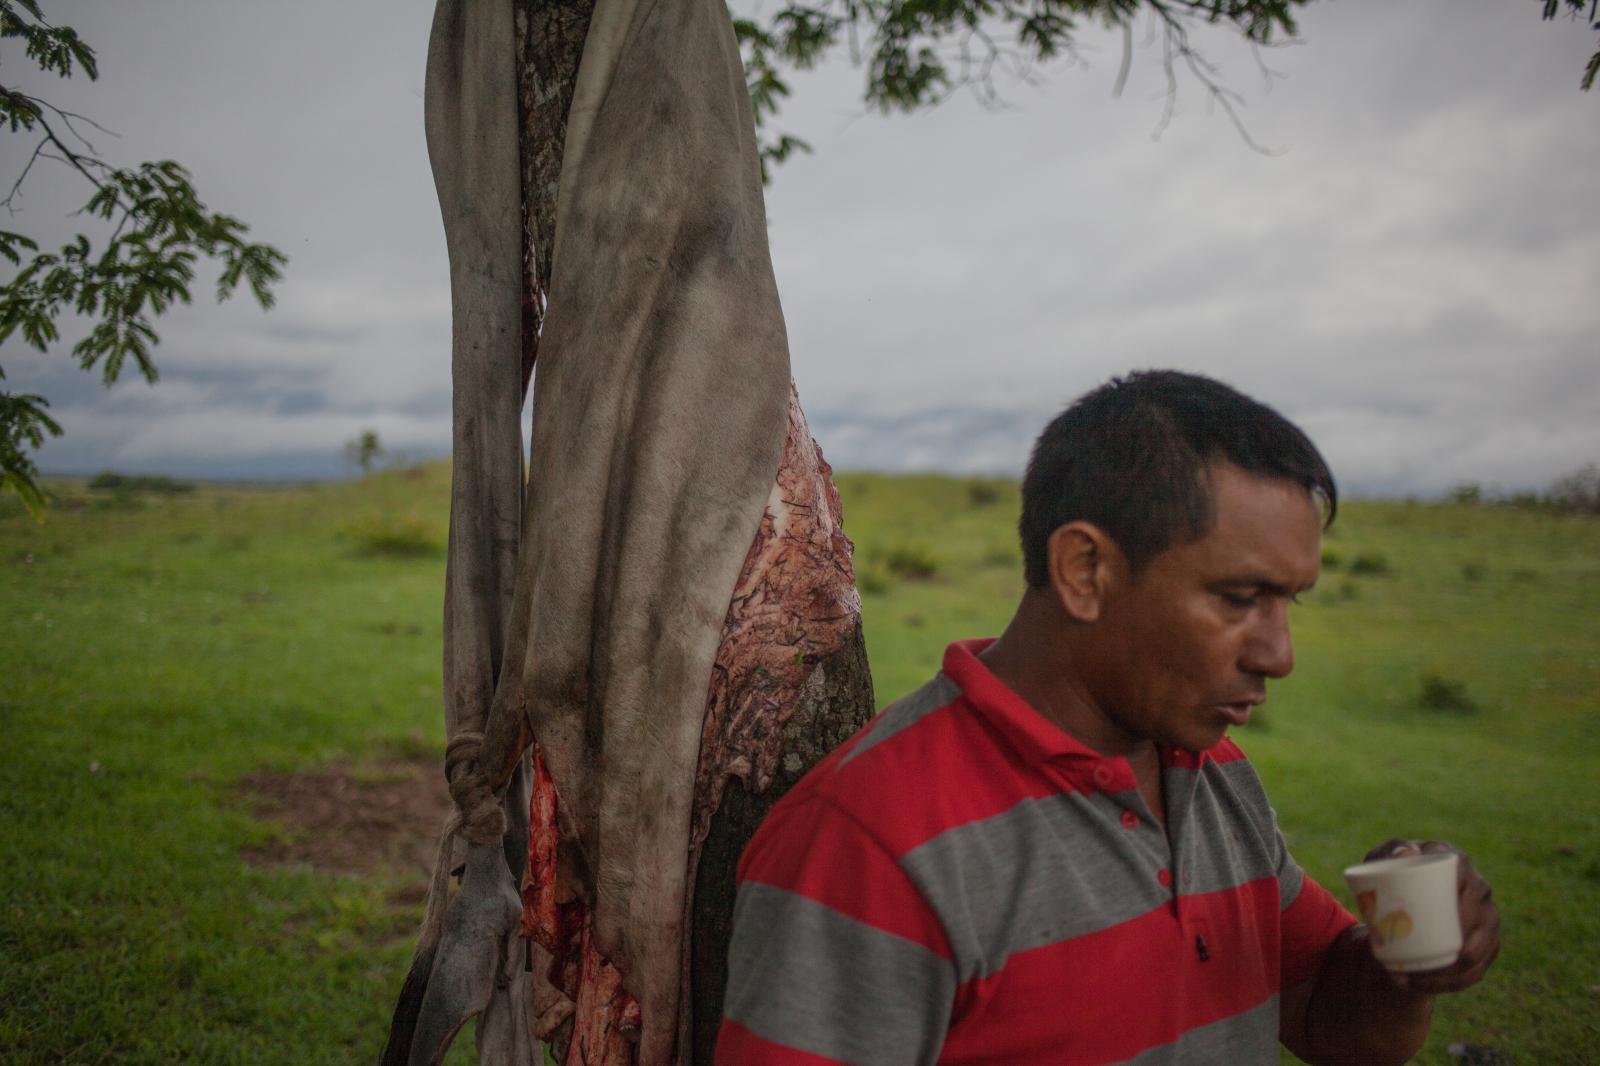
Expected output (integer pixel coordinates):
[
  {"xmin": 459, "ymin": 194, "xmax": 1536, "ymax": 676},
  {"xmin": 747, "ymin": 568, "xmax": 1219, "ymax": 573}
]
[{"xmin": 717, "ymin": 642, "xmax": 1355, "ymax": 1066}]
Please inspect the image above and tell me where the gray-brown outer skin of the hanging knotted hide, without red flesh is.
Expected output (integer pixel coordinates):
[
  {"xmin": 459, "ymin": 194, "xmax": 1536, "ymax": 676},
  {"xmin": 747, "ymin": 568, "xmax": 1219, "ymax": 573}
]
[{"xmin": 390, "ymin": 0, "xmax": 793, "ymax": 1064}]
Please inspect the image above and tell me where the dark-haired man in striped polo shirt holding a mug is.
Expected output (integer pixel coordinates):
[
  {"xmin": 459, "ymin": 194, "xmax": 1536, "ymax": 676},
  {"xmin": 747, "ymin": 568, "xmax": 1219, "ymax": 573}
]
[{"xmin": 717, "ymin": 371, "xmax": 1499, "ymax": 1066}]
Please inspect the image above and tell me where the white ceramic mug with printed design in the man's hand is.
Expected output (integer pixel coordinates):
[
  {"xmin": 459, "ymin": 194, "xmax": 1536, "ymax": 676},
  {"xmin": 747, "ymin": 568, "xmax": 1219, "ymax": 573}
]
[{"xmin": 1344, "ymin": 852, "xmax": 1461, "ymax": 973}]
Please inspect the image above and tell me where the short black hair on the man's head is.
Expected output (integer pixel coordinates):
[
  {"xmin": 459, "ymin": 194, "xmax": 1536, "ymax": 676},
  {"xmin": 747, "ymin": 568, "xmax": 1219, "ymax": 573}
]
[{"xmin": 1019, "ymin": 370, "xmax": 1339, "ymax": 589}]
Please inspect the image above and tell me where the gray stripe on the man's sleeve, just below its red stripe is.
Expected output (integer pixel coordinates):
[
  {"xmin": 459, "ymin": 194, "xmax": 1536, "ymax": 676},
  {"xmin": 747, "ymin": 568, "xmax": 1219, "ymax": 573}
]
[{"xmin": 723, "ymin": 882, "xmax": 955, "ymax": 1066}]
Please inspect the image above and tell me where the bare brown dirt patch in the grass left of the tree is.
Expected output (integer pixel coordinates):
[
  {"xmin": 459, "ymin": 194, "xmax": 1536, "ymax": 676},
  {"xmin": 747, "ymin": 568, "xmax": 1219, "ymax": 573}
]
[{"xmin": 240, "ymin": 759, "xmax": 450, "ymax": 892}]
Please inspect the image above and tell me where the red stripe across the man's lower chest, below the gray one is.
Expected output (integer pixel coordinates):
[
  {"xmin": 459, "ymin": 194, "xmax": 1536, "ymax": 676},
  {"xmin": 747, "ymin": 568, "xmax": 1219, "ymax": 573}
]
[{"xmin": 941, "ymin": 877, "xmax": 1278, "ymax": 1066}]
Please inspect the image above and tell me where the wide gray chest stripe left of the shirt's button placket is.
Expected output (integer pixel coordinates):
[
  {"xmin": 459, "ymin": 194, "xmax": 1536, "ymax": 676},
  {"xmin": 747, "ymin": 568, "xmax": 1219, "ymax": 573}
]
[{"xmin": 901, "ymin": 792, "xmax": 1168, "ymax": 981}]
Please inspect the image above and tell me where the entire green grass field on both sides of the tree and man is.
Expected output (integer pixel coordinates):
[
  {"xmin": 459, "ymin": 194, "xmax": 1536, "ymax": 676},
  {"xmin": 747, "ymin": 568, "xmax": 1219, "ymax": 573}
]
[{"xmin": 0, "ymin": 466, "xmax": 1600, "ymax": 1064}]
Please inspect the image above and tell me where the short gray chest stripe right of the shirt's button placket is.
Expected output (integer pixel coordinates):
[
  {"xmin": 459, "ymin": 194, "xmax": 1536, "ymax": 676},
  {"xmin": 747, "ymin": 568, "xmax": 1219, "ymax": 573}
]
[{"xmin": 1163, "ymin": 759, "xmax": 1283, "ymax": 895}]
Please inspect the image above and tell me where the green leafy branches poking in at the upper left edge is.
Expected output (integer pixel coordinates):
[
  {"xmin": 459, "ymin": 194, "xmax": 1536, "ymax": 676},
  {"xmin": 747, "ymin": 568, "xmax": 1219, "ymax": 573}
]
[{"xmin": 0, "ymin": 0, "xmax": 288, "ymax": 517}]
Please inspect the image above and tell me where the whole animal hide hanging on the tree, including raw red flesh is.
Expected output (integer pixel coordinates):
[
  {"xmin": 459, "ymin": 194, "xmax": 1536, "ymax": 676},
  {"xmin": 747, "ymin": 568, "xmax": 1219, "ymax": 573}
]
[{"xmin": 384, "ymin": 0, "xmax": 869, "ymax": 1066}]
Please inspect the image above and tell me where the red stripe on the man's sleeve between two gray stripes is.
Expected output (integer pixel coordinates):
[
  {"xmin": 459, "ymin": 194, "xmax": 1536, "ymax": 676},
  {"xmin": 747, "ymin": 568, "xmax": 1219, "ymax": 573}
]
[{"xmin": 739, "ymin": 799, "xmax": 950, "ymax": 959}]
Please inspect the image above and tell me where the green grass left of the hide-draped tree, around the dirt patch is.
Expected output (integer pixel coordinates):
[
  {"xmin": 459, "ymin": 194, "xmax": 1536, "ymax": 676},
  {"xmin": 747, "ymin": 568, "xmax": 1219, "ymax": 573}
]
[{"xmin": 0, "ymin": 469, "xmax": 464, "ymax": 1063}]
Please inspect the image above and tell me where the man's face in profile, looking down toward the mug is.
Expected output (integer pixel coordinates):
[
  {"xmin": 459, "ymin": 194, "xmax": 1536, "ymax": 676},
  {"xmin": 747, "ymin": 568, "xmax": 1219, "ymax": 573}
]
[{"xmin": 1083, "ymin": 463, "xmax": 1322, "ymax": 751}]
